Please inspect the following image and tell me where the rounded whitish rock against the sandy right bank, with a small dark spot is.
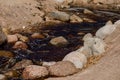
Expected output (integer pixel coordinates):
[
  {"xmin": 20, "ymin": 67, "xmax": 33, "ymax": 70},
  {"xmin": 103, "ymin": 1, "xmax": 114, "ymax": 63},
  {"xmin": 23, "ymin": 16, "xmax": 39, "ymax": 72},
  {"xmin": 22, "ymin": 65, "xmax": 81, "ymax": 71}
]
[{"xmin": 92, "ymin": 38, "xmax": 106, "ymax": 56}]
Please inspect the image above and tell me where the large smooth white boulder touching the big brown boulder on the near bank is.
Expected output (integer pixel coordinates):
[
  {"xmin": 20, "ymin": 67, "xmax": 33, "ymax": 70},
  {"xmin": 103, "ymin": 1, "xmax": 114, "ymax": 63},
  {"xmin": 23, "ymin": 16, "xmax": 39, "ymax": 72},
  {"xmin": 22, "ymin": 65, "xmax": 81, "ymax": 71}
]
[{"xmin": 63, "ymin": 51, "xmax": 87, "ymax": 69}]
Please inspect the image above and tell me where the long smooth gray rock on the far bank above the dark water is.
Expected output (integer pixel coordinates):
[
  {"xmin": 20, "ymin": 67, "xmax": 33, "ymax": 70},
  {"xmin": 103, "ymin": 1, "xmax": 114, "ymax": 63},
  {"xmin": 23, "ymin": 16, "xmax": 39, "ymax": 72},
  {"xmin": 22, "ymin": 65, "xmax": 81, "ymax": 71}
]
[{"xmin": 47, "ymin": 11, "xmax": 70, "ymax": 21}]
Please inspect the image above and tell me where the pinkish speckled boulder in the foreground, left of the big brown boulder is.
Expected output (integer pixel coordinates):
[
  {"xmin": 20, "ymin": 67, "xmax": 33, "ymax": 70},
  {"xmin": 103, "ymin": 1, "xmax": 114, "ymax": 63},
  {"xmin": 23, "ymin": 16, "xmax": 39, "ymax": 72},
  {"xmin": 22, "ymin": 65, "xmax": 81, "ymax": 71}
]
[{"xmin": 23, "ymin": 65, "xmax": 49, "ymax": 80}]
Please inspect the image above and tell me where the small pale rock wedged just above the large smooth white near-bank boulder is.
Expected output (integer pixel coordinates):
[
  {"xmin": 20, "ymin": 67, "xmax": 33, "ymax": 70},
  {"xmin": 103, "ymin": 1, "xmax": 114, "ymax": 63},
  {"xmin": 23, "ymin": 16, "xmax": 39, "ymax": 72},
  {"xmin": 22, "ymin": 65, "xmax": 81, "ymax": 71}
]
[{"xmin": 76, "ymin": 46, "xmax": 93, "ymax": 58}]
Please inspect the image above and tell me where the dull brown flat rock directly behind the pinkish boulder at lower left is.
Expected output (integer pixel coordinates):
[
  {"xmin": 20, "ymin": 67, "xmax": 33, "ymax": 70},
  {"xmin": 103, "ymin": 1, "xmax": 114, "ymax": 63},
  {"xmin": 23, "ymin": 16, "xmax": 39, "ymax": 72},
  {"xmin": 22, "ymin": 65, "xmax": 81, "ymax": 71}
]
[{"xmin": 12, "ymin": 59, "xmax": 33, "ymax": 70}]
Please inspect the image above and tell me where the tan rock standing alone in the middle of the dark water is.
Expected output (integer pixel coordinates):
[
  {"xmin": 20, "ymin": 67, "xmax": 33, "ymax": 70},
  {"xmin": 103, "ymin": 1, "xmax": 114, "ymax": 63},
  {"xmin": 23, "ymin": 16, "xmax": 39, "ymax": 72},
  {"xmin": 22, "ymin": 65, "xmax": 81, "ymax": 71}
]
[{"xmin": 50, "ymin": 36, "xmax": 69, "ymax": 46}]
